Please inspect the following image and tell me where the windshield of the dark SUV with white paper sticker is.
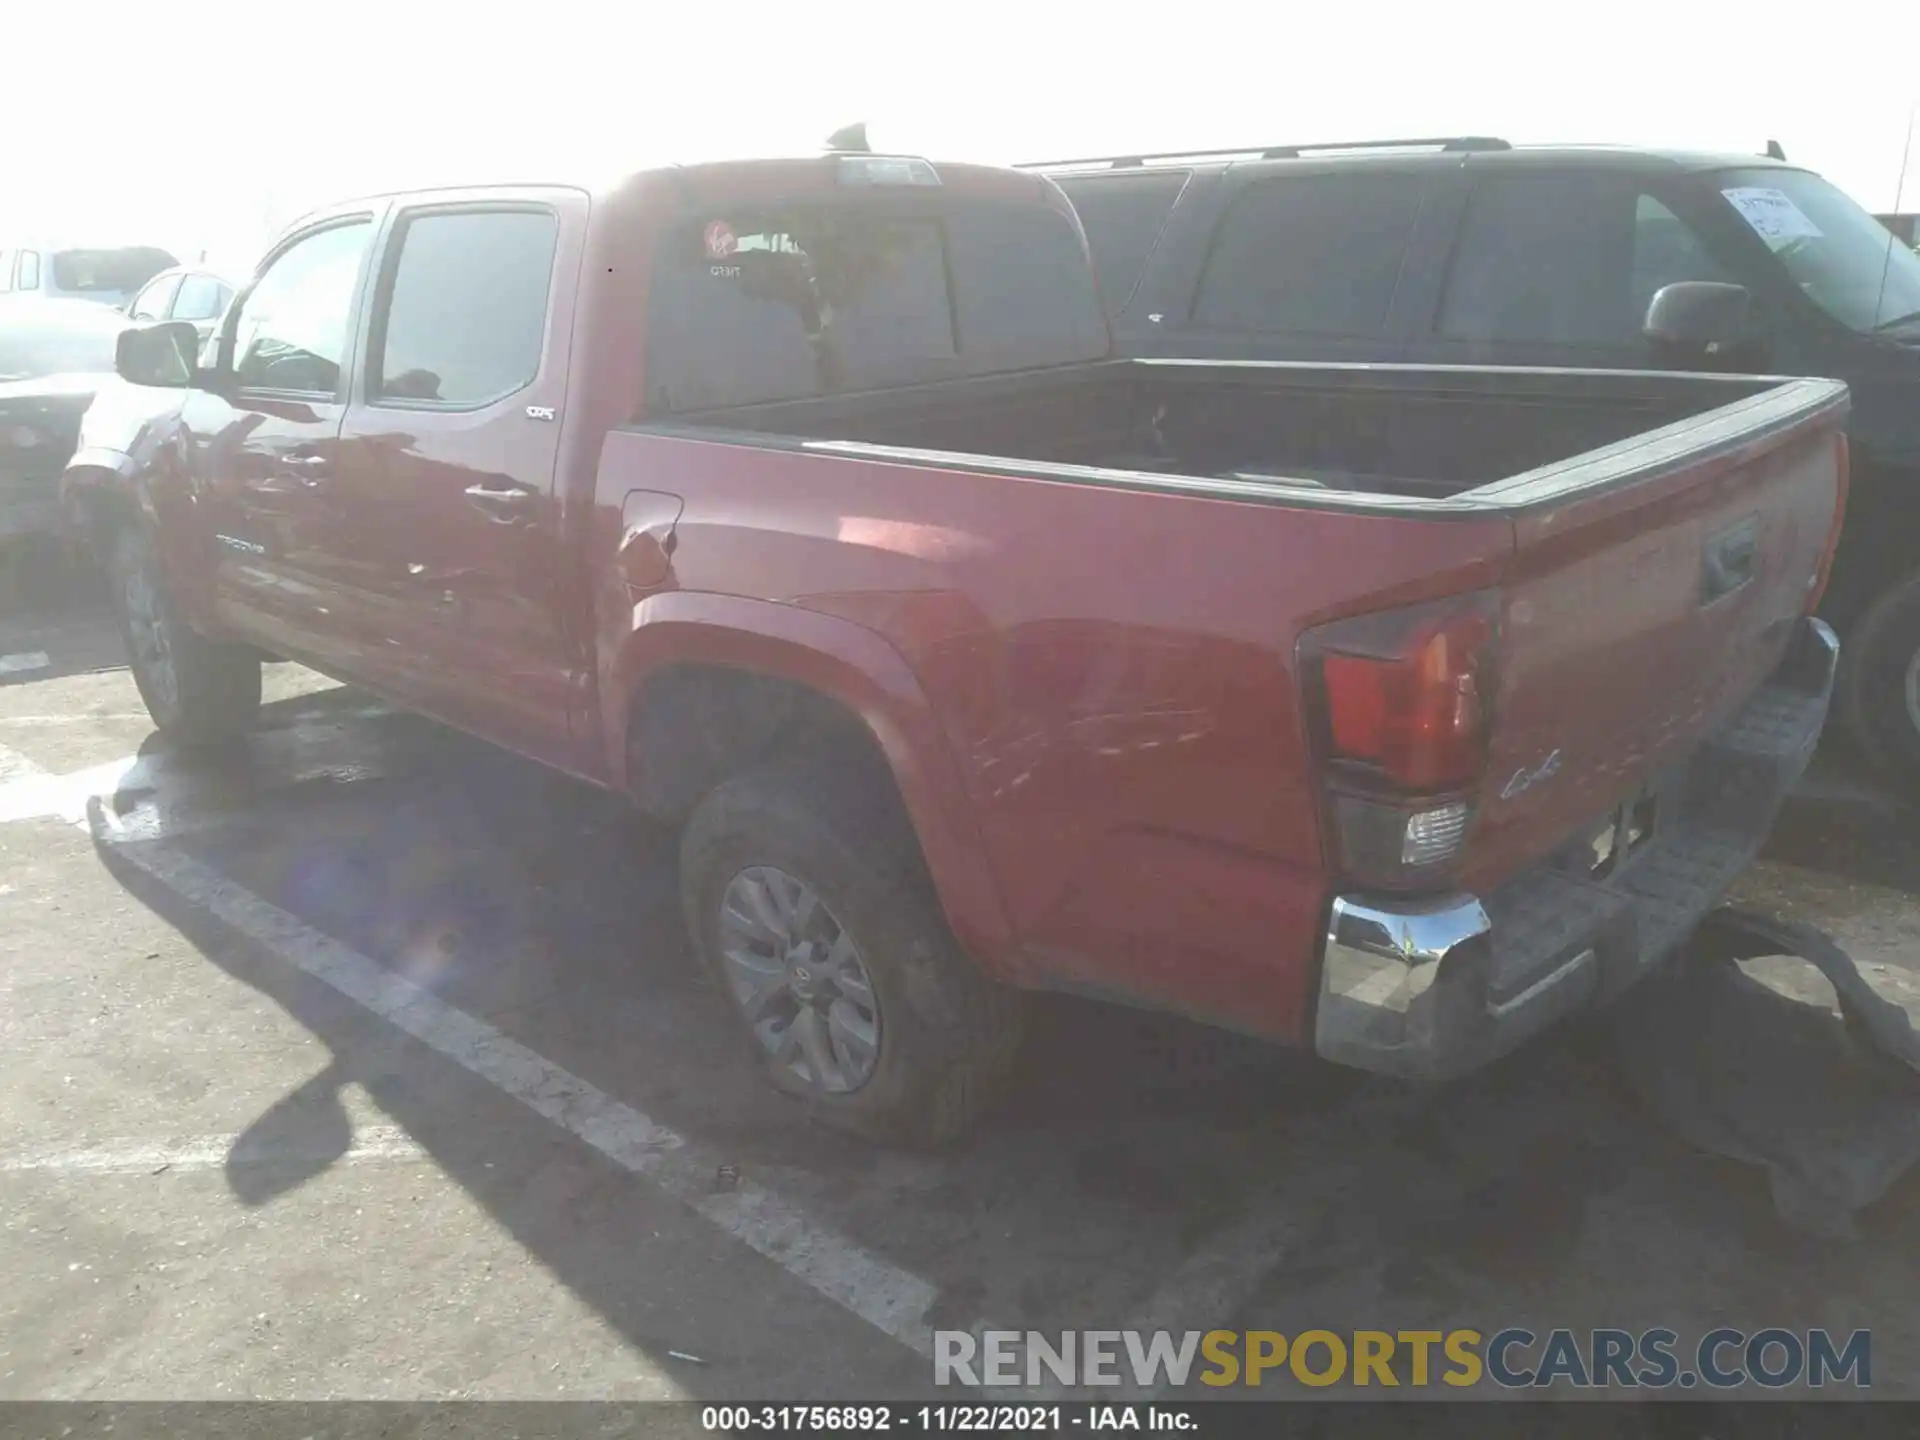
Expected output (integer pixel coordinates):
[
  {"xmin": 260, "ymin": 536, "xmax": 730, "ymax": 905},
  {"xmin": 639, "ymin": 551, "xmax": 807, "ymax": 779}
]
[{"xmin": 1716, "ymin": 169, "xmax": 1920, "ymax": 332}]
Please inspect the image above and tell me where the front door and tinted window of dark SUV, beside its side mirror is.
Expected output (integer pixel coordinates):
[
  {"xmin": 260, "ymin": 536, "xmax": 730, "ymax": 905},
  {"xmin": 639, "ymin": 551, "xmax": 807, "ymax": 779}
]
[{"xmin": 1405, "ymin": 161, "xmax": 1741, "ymax": 369}]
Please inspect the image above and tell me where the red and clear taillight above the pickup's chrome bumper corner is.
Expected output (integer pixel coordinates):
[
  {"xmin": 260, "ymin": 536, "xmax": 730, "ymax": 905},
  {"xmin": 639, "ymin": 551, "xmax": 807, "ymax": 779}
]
[{"xmin": 1300, "ymin": 591, "xmax": 1500, "ymax": 889}]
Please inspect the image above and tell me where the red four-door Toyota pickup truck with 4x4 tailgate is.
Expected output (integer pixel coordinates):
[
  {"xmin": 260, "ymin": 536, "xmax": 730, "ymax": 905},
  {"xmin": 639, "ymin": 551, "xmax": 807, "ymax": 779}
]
[{"xmin": 65, "ymin": 154, "xmax": 1847, "ymax": 1140}]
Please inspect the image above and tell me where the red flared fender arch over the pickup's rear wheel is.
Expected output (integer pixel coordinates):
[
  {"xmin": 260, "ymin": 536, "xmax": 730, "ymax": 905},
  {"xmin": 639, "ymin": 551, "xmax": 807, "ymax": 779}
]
[{"xmin": 601, "ymin": 591, "xmax": 1027, "ymax": 983}]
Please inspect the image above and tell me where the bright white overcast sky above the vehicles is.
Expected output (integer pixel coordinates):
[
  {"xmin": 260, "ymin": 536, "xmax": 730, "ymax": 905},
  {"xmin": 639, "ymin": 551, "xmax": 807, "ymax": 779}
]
[{"xmin": 0, "ymin": 0, "xmax": 1920, "ymax": 271}]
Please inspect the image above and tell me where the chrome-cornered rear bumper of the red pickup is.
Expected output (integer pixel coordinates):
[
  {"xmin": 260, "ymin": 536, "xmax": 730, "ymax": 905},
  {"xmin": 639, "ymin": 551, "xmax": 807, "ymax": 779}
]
[{"xmin": 1313, "ymin": 620, "xmax": 1839, "ymax": 1079}]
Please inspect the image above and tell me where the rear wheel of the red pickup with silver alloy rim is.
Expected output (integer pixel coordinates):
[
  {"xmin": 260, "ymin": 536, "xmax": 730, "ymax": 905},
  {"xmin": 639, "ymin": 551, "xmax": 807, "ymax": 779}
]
[{"xmin": 680, "ymin": 764, "xmax": 1025, "ymax": 1144}]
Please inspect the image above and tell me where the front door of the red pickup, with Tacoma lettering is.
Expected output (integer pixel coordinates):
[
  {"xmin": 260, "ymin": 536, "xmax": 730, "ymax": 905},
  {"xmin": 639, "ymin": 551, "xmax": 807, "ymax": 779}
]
[{"xmin": 199, "ymin": 215, "xmax": 385, "ymax": 666}]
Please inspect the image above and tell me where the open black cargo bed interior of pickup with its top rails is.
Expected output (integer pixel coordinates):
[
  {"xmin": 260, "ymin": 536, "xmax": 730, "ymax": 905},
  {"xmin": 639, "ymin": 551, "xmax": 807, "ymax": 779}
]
[{"xmin": 647, "ymin": 359, "xmax": 1832, "ymax": 513}]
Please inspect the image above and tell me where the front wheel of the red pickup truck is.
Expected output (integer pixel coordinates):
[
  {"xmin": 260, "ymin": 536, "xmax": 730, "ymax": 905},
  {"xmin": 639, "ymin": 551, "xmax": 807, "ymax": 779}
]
[{"xmin": 109, "ymin": 526, "xmax": 259, "ymax": 747}]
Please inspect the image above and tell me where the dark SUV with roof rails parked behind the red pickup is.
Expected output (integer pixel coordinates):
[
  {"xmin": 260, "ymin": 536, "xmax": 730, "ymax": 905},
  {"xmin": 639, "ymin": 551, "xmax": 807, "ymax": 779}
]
[{"xmin": 1029, "ymin": 136, "xmax": 1920, "ymax": 787}]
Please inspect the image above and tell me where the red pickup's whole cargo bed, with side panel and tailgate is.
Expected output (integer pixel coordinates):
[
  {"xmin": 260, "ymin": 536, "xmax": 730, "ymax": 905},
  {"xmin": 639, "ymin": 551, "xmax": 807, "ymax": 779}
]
[{"xmin": 614, "ymin": 349, "xmax": 1847, "ymax": 1035}]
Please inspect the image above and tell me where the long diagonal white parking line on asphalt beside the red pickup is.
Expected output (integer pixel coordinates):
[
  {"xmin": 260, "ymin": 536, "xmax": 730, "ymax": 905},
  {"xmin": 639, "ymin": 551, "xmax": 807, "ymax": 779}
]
[{"xmin": 90, "ymin": 821, "xmax": 956, "ymax": 1356}]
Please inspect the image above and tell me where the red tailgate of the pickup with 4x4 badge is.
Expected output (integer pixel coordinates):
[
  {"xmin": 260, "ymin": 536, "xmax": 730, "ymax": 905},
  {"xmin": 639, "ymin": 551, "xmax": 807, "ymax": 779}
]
[{"xmin": 1463, "ymin": 382, "xmax": 1847, "ymax": 883}]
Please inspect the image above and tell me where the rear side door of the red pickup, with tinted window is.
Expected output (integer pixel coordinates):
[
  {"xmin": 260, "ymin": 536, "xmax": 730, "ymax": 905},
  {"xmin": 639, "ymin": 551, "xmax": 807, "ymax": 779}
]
[{"xmin": 330, "ymin": 188, "xmax": 586, "ymax": 766}]
